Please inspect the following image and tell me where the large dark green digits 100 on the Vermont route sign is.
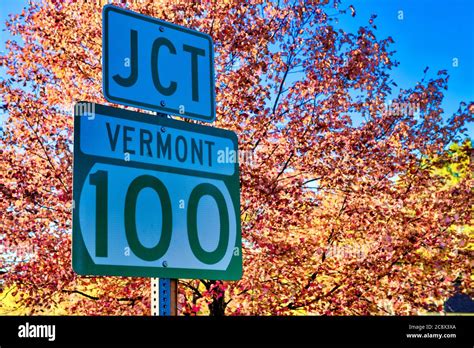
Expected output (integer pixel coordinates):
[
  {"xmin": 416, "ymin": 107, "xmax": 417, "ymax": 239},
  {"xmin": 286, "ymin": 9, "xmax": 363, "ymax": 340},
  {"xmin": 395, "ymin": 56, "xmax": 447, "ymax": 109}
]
[{"xmin": 89, "ymin": 170, "xmax": 229, "ymax": 264}]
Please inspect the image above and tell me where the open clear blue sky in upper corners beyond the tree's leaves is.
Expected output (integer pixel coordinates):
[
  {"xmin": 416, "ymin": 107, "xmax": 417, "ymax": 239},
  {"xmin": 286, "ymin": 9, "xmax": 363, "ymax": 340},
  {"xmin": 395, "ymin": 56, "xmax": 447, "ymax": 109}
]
[{"xmin": 0, "ymin": 0, "xmax": 474, "ymax": 138}]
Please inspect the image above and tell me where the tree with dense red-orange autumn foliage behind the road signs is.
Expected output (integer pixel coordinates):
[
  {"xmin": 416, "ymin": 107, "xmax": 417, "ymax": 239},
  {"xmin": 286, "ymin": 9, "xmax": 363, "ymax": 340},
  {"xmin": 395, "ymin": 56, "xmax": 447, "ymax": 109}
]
[{"xmin": 0, "ymin": 0, "xmax": 474, "ymax": 315}]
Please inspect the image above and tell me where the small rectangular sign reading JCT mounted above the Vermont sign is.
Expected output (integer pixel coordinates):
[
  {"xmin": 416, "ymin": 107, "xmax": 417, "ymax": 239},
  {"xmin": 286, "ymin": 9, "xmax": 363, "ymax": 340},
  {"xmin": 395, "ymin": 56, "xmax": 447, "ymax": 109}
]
[{"xmin": 103, "ymin": 5, "xmax": 215, "ymax": 122}]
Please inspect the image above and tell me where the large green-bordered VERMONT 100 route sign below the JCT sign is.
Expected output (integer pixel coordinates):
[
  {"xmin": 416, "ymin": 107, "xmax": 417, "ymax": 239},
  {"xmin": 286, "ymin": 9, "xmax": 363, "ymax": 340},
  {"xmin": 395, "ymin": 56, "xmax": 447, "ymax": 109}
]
[{"xmin": 72, "ymin": 103, "xmax": 242, "ymax": 280}]
